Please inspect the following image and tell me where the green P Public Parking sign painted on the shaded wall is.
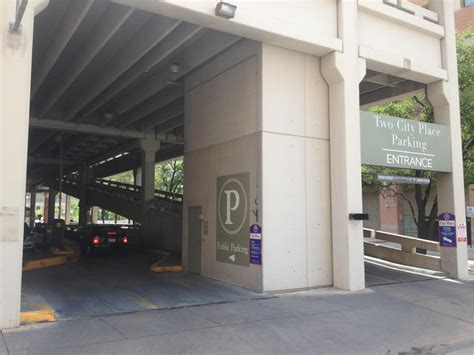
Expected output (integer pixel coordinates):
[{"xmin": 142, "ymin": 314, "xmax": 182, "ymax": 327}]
[{"xmin": 216, "ymin": 173, "xmax": 250, "ymax": 266}]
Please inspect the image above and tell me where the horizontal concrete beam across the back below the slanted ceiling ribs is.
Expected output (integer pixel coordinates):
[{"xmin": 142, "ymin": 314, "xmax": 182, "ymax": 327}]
[{"xmin": 30, "ymin": 117, "xmax": 183, "ymax": 144}]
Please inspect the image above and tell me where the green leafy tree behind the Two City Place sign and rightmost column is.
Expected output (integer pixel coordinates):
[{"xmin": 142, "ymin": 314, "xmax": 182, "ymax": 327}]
[{"xmin": 362, "ymin": 29, "xmax": 474, "ymax": 243}]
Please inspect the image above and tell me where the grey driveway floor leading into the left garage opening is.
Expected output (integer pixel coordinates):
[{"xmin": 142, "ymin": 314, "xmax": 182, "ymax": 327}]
[{"xmin": 22, "ymin": 254, "xmax": 270, "ymax": 320}]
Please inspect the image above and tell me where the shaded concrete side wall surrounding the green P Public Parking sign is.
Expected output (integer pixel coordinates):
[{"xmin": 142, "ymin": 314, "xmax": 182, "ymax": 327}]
[{"xmin": 183, "ymin": 40, "xmax": 262, "ymax": 290}]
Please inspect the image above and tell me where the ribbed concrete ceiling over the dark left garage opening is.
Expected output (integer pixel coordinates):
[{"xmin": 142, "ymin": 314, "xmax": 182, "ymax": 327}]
[{"xmin": 28, "ymin": 0, "xmax": 239, "ymax": 187}]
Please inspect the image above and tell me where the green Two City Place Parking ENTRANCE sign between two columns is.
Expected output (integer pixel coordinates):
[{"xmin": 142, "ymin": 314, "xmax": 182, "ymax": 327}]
[{"xmin": 360, "ymin": 111, "xmax": 452, "ymax": 172}]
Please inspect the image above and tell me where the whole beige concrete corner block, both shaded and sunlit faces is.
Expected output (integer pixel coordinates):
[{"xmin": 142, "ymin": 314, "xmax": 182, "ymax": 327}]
[{"xmin": 183, "ymin": 40, "xmax": 332, "ymax": 290}]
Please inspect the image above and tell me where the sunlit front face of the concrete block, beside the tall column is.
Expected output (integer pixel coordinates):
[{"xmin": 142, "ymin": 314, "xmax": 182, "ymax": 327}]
[{"xmin": 262, "ymin": 45, "xmax": 332, "ymax": 290}]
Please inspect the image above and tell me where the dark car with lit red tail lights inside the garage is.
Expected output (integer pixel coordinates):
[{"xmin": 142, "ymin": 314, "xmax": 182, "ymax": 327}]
[{"xmin": 79, "ymin": 226, "xmax": 130, "ymax": 256}]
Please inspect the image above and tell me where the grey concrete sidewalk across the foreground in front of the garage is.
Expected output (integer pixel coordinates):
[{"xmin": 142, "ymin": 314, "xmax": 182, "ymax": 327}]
[{"xmin": 4, "ymin": 280, "xmax": 474, "ymax": 355}]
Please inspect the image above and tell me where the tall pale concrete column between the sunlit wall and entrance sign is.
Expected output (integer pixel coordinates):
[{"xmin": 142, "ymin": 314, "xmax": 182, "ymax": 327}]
[{"xmin": 321, "ymin": 0, "xmax": 365, "ymax": 290}]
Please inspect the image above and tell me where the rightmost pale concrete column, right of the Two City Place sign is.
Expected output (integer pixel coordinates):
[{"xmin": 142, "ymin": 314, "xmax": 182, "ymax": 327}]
[{"xmin": 427, "ymin": 0, "xmax": 468, "ymax": 280}]
